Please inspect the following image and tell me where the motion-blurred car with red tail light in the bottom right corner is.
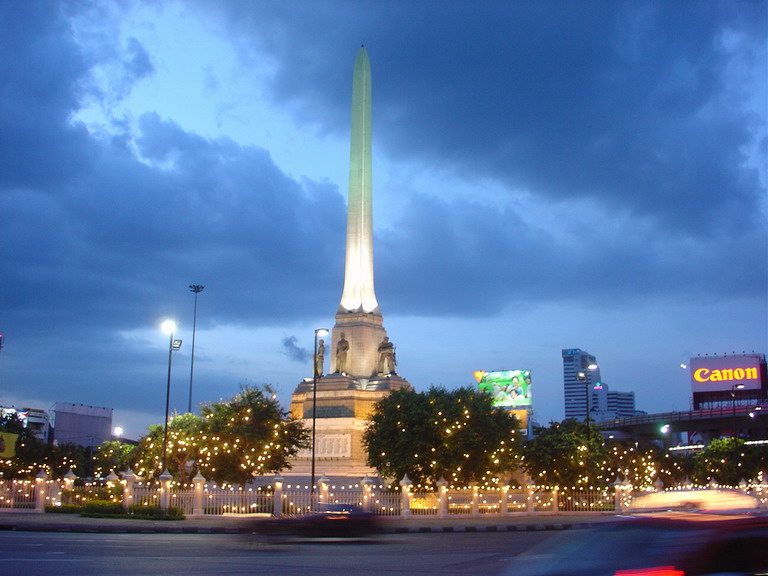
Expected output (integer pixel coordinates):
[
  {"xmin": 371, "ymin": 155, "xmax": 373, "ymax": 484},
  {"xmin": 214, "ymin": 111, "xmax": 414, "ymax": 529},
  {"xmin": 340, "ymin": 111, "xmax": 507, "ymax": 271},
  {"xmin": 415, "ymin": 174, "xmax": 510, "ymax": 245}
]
[{"xmin": 502, "ymin": 512, "xmax": 768, "ymax": 576}]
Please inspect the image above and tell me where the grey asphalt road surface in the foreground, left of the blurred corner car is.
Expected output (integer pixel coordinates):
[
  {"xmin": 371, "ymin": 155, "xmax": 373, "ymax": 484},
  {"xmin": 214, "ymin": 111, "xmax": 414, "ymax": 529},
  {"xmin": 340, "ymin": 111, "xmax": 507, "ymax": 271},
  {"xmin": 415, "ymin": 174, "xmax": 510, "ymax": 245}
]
[{"xmin": 0, "ymin": 531, "xmax": 554, "ymax": 576}]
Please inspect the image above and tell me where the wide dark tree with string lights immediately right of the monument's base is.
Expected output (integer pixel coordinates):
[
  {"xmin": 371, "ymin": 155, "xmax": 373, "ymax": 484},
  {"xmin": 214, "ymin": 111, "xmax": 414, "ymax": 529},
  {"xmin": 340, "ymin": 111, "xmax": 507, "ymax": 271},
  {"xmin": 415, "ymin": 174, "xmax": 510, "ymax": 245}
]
[{"xmin": 363, "ymin": 386, "xmax": 520, "ymax": 487}]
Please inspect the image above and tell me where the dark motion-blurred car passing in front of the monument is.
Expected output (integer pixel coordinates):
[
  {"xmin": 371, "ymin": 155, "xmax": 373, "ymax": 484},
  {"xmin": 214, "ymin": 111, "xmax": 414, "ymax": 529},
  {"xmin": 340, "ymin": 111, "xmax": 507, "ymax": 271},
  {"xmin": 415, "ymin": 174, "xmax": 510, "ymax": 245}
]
[{"xmin": 256, "ymin": 504, "xmax": 381, "ymax": 538}]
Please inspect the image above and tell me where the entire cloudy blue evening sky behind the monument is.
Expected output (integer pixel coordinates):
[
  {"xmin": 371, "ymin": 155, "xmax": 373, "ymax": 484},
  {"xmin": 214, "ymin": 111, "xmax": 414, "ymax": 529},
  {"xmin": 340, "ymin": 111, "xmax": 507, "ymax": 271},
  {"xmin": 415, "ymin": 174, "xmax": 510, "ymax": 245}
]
[{"xmin": 0, "ymin": 0, "xmax": 768, "ymax": 438}]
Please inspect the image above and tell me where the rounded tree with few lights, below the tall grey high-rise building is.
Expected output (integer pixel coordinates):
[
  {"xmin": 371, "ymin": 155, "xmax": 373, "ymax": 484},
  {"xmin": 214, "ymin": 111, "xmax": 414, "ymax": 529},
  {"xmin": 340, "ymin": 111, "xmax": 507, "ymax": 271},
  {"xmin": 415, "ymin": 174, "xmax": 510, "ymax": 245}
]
[{"xmin": 522, "ymin": 418, "xmax": 608, "ymax": 488}]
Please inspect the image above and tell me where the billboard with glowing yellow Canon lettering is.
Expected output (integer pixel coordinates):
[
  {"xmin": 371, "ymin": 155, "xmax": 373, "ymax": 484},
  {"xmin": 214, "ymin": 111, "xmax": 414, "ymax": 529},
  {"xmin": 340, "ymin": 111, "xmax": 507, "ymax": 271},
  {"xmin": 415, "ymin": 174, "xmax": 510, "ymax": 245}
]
[{"xmin": 690, "ymin": 354, "xmax": 763, "ymax": 392}]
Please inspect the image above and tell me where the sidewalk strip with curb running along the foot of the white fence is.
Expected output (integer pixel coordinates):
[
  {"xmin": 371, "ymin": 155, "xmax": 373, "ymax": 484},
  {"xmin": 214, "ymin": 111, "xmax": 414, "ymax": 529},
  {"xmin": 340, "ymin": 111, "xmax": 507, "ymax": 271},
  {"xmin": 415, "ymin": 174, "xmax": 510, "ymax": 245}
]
[{"xmin": 0, "ymin": 511, "xmax": 615, "ymax": 534}]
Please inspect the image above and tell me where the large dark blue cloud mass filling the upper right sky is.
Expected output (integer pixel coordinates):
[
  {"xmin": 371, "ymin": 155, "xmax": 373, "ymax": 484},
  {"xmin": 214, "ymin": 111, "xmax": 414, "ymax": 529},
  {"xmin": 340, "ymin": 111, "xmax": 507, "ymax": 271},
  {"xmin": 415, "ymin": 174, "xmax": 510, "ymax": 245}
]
[{"xmin": 207, "ymin": 1, "xmax": 767, "ymax": 237}]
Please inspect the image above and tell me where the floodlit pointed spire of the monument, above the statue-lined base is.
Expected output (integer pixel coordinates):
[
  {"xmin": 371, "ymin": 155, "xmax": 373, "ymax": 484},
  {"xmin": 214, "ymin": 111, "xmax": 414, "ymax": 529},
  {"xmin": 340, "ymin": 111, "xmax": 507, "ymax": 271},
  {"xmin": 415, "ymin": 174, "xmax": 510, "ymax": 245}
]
[{"xmin": 339, "ymin": 46, "xmax": 379, "ymax": 314}]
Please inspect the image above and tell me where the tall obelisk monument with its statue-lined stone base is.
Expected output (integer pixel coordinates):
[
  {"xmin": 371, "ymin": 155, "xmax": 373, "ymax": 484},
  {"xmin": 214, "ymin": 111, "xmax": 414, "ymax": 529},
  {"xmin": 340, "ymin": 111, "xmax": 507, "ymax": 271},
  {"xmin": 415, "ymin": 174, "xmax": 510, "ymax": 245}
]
[{"xmin": 291, "ymin": 46, "xmax": 410, "ymax": 477}]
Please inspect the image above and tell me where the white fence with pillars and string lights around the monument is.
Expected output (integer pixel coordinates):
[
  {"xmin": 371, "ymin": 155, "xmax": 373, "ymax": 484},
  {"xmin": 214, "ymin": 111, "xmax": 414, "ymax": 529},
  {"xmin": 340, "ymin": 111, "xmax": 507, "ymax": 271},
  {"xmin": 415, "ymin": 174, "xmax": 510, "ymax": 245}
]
[{"xmin": 6, "ymin": 470, "xmax": 768, "ymax": 518}]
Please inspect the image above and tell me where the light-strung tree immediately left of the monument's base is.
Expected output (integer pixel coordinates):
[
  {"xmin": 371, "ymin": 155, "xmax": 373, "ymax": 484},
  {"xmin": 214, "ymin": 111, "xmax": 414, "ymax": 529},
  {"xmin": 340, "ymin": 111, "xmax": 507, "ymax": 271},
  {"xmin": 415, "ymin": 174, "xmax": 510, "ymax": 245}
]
[{"xmin": 198, "ymin": 386, "xmax": 309, "ymax": 484}]
